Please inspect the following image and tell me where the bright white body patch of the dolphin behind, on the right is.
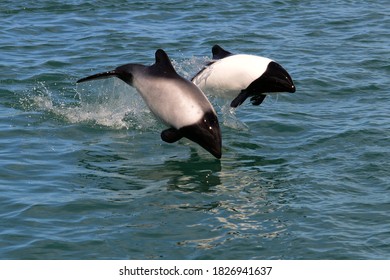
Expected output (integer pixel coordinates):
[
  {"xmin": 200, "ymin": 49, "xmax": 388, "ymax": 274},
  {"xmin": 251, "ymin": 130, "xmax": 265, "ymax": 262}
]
[{"xmin": 192, "ymin": 54, "xmax": 272, "ymax": 98}]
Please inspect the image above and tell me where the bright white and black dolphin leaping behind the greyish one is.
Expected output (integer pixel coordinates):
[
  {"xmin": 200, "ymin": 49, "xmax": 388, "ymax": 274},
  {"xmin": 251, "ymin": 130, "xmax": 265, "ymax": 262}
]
[{"xmin": 191, "ymin": 45, "xmax": 295, "ymax": 108}]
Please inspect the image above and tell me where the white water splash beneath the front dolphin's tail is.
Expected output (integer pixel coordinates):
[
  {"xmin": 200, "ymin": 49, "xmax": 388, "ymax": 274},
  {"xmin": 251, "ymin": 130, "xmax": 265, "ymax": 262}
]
[{"xmin": 28, "ymin": 79, "xmax": 157, "ymax": 130}]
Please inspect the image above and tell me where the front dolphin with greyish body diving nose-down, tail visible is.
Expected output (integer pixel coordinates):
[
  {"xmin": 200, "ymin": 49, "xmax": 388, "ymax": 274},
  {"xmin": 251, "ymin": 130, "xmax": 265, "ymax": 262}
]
[{"xmin": 77, "ymin": 49, "xmax": 222, "ymax": 158}]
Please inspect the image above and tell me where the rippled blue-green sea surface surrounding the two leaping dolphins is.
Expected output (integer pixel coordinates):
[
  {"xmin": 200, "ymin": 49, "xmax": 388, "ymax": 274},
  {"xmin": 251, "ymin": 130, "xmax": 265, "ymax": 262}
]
[{"xmin": 0, "ymin": 0, "xmax": 390, "ymax": 259}]
